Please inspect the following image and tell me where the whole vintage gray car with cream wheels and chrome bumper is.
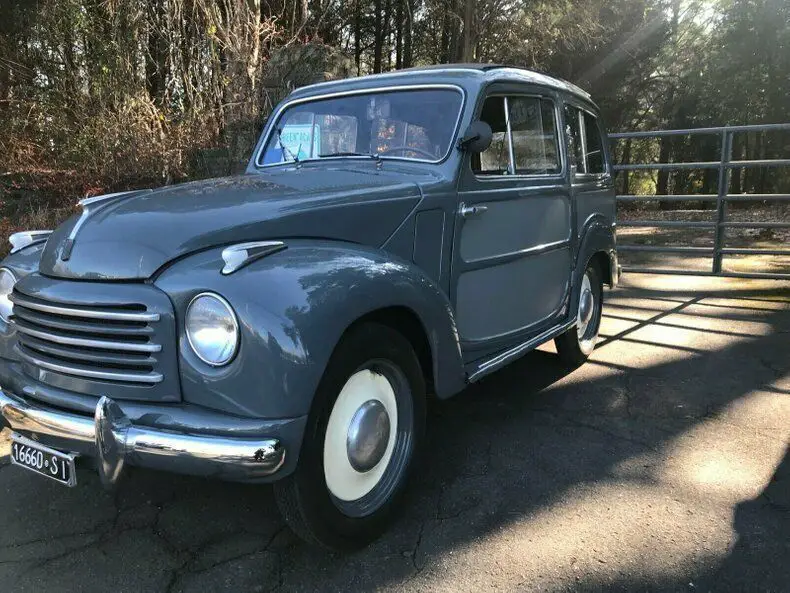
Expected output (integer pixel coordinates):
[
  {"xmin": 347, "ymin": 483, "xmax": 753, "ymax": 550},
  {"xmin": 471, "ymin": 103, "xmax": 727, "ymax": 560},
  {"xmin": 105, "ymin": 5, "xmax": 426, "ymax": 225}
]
[{"xmin": 0, "ymin": 65, "xmax": 618, "ymax": 548}]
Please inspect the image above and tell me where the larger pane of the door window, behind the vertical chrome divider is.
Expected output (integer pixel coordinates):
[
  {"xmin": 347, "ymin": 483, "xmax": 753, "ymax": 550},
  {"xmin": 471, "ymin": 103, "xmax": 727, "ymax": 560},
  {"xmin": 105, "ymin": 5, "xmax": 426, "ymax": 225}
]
[{"xmin": 508, "ymin": 97, "xmax": 560, "ymax": 175}]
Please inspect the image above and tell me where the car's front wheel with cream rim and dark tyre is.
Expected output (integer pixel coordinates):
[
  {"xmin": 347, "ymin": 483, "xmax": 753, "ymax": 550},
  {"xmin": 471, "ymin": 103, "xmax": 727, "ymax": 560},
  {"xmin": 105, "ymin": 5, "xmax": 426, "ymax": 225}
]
[{"xmin": 274, "ymin": 323, "xmax": 425, "ymax": 549}]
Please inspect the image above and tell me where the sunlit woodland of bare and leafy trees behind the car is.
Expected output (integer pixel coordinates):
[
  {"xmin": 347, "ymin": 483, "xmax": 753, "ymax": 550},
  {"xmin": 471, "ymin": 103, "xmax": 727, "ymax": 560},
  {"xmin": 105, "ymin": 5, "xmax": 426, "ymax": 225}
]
[{"xmin": 0, "ymin": 0, "xmax": 790, "ymax": 234}]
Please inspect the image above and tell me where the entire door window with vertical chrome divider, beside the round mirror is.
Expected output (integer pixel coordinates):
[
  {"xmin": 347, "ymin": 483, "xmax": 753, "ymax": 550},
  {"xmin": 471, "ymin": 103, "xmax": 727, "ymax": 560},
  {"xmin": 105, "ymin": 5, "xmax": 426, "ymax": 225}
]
[{"xmin": 472, "ymin": 96, "xmax": 562, "ymax": 175}]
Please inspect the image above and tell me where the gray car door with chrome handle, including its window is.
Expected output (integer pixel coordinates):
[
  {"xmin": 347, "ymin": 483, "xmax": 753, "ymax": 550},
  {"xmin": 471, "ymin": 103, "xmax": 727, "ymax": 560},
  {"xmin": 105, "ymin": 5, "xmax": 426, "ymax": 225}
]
[{"xmin": 451, "ymin": 86, "xmax": 572, "ymax": 360}]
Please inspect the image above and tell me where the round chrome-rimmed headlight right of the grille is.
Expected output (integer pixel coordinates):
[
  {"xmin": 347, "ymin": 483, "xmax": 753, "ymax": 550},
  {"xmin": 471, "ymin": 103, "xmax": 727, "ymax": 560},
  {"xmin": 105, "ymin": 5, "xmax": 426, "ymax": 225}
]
[{"xmin": 186, "ymin": 292, "xmax": 239, "ymax": 366}]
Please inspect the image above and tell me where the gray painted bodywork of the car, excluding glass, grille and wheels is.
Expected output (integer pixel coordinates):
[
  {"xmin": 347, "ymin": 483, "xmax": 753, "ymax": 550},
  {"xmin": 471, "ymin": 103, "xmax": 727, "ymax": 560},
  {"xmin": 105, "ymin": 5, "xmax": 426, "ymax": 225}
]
[{"xmin": 0, "ymin": 67, "xmax": 615, "ymax": 476}]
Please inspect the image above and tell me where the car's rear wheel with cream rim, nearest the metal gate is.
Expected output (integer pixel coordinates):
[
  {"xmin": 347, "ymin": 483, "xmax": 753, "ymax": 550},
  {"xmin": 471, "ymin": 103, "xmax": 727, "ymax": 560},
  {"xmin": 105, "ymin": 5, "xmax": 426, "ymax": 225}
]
[{"xmin": 554, "ymin": 264, "xmax": 603, "ymax": 367}]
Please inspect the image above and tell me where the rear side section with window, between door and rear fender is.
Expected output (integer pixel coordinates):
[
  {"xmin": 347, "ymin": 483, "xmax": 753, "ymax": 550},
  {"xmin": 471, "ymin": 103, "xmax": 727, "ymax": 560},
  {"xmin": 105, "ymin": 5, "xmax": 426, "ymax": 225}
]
[{"xmin": 563, "ymin": 102, "xmax": 615, "ymax": 250}]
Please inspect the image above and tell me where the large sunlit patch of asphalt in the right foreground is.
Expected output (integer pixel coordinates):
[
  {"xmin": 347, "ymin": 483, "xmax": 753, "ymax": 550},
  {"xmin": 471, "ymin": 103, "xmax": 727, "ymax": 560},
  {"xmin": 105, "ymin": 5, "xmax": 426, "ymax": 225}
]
[{"xmin": 420, "ymin": 386, "xmax": 790, "ymax": 592}]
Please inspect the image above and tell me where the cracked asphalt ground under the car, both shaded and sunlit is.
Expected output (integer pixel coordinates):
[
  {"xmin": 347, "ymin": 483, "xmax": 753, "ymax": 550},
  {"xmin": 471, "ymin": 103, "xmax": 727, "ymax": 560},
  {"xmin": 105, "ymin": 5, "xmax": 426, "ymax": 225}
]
[{"xmin": 0, "ymin": 275, "xmax": 790, "ymax": 593}]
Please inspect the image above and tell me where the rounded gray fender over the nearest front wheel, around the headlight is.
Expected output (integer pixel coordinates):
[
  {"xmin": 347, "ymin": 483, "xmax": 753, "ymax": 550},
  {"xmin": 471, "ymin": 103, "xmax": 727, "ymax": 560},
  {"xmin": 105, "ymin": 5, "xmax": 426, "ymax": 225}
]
[{"xmin": 155, "ymin": 240, "xmax": 465, "ymax": 418}]
